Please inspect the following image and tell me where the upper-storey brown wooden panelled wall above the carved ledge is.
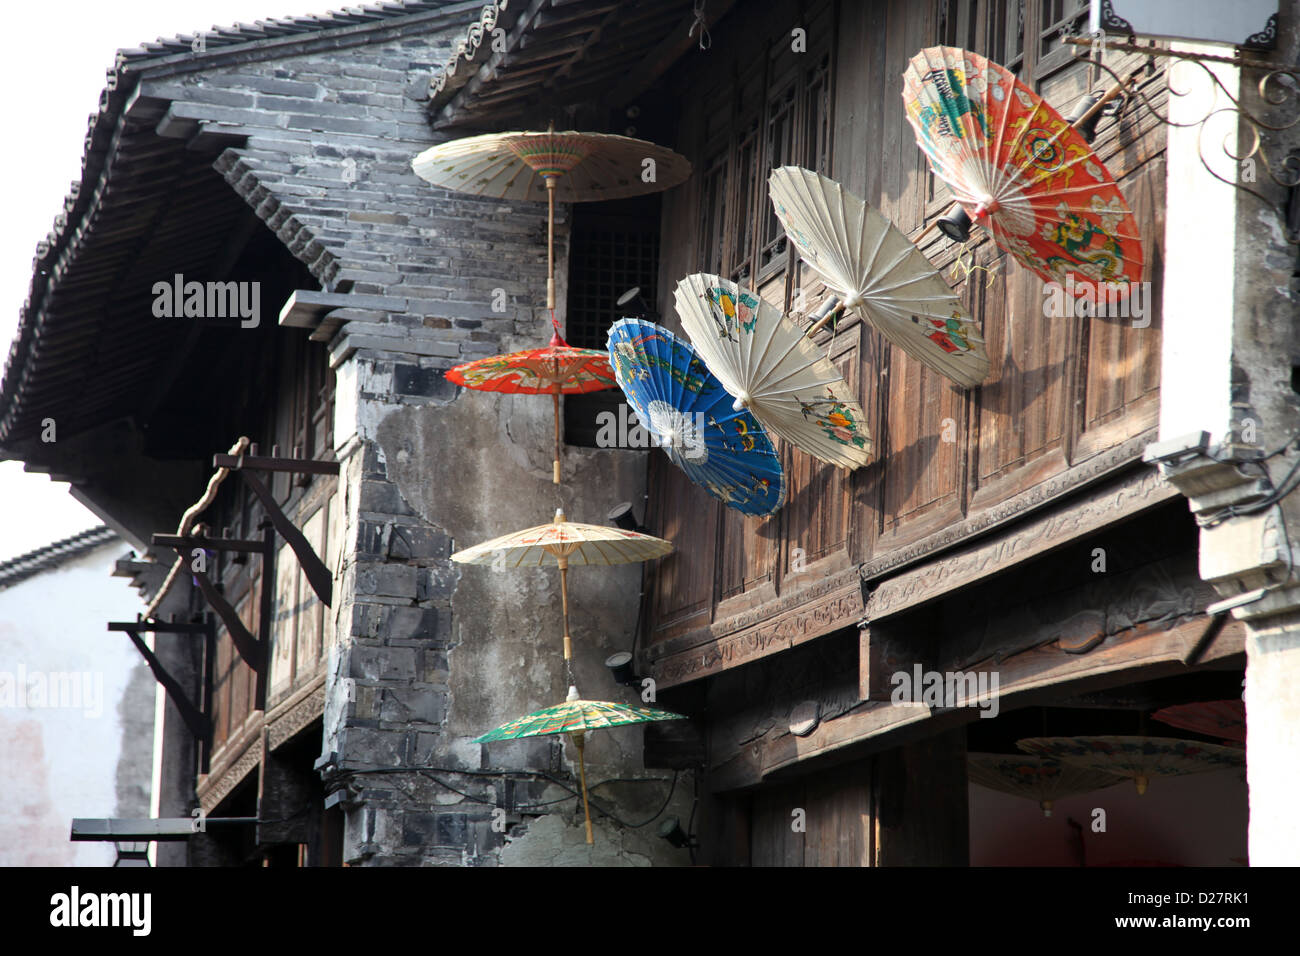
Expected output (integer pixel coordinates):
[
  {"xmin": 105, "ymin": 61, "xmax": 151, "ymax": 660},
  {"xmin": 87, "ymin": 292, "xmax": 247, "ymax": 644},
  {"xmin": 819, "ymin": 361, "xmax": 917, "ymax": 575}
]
[{"xmin": 646, "ymin": 0, "xmax": 1165, "ymax": 671}]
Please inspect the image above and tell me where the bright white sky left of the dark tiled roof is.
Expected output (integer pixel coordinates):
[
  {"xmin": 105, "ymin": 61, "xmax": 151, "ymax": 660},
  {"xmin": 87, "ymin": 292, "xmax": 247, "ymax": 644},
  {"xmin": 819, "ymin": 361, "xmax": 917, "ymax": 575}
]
[{"xmin": 0, "ymin": 0, "xmax": 351, "ymax": 561}]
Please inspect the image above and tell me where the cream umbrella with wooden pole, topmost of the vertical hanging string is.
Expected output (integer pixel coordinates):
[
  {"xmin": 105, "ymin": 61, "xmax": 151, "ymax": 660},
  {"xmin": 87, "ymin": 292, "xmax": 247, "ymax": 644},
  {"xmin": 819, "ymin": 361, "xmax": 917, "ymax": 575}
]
[{"xmin": 411, "ymin": 129, "xmax": 690, "ymax": 310}]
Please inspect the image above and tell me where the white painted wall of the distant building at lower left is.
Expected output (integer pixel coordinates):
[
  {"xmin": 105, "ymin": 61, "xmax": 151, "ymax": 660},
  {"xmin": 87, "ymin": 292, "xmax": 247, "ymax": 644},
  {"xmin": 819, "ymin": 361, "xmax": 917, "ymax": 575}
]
[{"xmin": 0, "ymin": 540, "xmax": 155, "ymax": 866}]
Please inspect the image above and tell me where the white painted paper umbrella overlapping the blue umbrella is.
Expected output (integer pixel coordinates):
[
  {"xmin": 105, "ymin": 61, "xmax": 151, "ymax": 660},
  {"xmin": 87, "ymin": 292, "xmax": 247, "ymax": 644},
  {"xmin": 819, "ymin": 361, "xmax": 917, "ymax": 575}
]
[{"xmin": 676, "ymin": 273, "xmax": 871, "ymax": 470}]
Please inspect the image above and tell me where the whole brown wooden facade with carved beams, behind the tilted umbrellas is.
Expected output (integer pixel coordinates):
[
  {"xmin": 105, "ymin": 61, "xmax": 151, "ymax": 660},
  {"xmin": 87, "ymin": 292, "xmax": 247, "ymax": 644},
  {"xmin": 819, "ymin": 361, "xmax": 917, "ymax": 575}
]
[{"xmin": 618, "ymin": 0, "xmax": 1244, "ymax": 865}]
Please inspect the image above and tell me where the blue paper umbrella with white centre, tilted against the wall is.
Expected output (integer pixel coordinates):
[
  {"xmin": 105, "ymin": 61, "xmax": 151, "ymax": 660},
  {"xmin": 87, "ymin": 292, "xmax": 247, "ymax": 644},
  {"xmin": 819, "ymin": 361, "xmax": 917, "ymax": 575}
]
[{"xmin": 610, "ymin": 319, "xmax": 785, "ymax": 515}]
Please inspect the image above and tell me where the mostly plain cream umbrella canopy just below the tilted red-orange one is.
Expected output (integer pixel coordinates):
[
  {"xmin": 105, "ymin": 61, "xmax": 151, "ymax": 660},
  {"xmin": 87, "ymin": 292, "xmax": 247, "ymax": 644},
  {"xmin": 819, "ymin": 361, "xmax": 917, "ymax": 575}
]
[{"xmin": 768, "ymin": 166, "xmax": 988, "ymax": 388}]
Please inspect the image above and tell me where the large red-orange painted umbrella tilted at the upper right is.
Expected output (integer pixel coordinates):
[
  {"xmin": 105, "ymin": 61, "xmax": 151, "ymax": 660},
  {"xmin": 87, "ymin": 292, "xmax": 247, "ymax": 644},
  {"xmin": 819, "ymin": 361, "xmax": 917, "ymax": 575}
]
[{"xmin": 902, "ymin": 47, "xmax": 1143, "ymax": 302}]
